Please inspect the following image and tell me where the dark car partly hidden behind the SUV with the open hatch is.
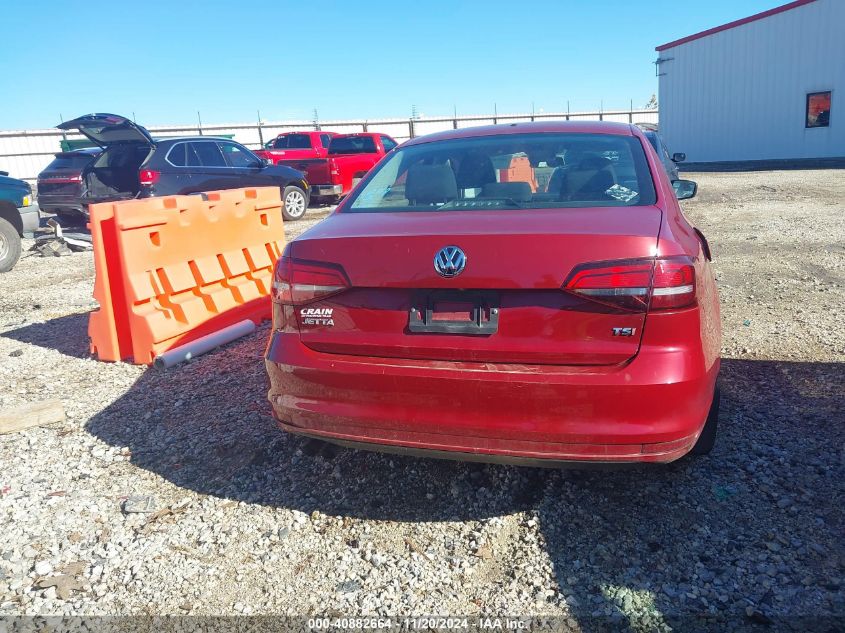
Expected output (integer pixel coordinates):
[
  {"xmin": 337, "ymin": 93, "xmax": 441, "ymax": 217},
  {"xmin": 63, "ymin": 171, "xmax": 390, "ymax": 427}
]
[{"xmin": 37, "ymin": 147, "xmax": 103, "ymax": 222}]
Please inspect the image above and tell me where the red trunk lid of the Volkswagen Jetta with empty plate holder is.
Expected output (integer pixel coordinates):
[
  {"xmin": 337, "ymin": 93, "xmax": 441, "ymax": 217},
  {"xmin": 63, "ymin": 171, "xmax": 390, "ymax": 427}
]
[{"xmin": 290, "ymin": 207, "xmax": 661, "ymax": 365}]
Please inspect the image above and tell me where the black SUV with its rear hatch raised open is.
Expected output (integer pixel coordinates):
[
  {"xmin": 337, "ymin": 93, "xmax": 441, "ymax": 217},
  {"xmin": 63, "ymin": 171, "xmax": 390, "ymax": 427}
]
[{"xmin": 57, "ymin": 114, "xmax": 310, "ymax": 220}]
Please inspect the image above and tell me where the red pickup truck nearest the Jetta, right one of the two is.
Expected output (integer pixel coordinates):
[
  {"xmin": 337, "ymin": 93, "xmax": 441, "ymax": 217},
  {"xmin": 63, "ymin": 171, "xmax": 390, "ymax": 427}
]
[{"xmin": 278, "ymin": 132, "xmax": 397, "ymax": 202}]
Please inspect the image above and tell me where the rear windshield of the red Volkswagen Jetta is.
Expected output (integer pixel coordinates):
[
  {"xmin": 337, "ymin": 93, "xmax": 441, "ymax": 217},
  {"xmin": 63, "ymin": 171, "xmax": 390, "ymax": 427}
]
[{"xmin": 346, "ymin": 133, "xmax": 657, "ymax": 212}]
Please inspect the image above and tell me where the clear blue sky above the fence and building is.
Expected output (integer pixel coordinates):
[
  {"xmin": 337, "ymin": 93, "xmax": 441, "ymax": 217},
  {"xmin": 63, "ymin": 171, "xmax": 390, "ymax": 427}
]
[{"xmin": 0, "ymin": 0, "xmax": 782, "ymax": 130}]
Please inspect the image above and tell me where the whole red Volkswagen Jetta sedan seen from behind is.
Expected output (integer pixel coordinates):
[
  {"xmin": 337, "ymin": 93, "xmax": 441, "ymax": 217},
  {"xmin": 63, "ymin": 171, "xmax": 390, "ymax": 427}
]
[{"xmin": 266, "ymin": 122, "xmax": 720, "ymax": 464}]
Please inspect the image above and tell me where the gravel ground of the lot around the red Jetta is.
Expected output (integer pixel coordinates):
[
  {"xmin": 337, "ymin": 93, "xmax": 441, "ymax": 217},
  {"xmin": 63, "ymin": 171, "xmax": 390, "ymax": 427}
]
[{"xmin": 0, "ymin": 170, "xmax": 845, "ymax": 631}]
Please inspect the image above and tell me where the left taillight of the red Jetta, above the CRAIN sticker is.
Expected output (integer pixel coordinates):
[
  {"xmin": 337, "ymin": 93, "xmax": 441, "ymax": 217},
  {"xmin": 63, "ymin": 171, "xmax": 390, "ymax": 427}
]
[{"xmin": 273, "ymin": 257, "xmax": 349, "ymax": 305}]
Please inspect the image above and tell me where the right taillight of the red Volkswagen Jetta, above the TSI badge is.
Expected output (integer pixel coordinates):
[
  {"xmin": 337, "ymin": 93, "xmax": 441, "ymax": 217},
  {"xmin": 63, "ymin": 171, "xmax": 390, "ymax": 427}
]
[{"xmin": 563, "ymin": 257, "xmax": 695, "ymax": 312}]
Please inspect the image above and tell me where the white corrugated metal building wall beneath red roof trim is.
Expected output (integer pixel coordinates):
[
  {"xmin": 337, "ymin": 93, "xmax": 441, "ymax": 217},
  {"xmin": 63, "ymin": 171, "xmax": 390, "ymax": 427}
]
[{"xmin": 658, "ymin": 0, "xmax": 845, "ymax": 162}]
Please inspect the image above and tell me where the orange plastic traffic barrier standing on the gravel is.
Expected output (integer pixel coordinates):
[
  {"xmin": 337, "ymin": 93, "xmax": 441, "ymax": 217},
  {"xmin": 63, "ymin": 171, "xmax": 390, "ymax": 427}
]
[{"xmin": 88, "ymin": 187, "xmax": 285, "ymax": 364}]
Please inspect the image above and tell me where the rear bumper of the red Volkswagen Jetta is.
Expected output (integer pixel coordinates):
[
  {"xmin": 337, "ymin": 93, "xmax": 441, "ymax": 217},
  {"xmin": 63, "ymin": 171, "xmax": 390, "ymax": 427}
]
[{"xmin": 266, "ymin": 332, "xmax": 719, "ymax": 465}]
